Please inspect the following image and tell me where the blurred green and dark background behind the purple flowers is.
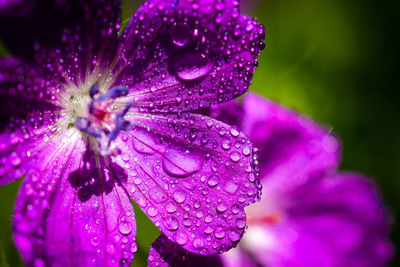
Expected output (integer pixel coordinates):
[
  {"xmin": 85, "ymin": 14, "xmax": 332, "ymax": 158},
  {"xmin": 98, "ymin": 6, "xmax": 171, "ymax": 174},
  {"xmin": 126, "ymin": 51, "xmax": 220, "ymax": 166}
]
[{"xmin": 0, "ymin": 0, "xmax": 400, "ymax": 267}]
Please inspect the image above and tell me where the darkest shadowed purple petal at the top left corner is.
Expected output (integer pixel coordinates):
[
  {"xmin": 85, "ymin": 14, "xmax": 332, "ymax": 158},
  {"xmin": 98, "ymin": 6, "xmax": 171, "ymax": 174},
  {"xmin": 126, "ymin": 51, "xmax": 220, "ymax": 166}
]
[{"xmin": 0, "ymin": 0, "xmax": 121, "ymax": 84}]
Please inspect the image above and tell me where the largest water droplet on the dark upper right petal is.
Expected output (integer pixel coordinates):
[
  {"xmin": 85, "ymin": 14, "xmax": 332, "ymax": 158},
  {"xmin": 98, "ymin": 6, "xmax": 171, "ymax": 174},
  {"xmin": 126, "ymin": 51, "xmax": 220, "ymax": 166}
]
[{"xmin": 173, "ymin": 53, "xmax": 213, "ymax": 82}]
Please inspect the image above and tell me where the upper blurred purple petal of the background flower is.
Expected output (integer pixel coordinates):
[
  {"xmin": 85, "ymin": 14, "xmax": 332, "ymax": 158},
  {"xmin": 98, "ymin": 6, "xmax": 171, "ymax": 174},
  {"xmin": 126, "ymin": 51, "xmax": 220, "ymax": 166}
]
[{"xmin": 213, "ymin": 94, "xmax": 340, "ymax": 195}]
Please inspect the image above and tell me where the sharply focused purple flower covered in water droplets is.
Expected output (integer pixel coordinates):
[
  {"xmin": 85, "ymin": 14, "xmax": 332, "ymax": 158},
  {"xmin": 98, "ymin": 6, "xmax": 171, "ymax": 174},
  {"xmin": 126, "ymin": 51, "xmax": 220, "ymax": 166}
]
[{"xmin": 0, "ymin": 0, "xmax": 264, "ymax": 266}]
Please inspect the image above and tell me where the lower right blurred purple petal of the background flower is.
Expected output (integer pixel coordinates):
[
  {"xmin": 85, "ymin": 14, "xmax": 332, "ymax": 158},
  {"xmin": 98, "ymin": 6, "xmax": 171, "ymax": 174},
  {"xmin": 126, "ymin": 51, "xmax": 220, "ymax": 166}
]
[{"xmin": 241, "ymin": 173, "xmax": 394, "ymax": 267}]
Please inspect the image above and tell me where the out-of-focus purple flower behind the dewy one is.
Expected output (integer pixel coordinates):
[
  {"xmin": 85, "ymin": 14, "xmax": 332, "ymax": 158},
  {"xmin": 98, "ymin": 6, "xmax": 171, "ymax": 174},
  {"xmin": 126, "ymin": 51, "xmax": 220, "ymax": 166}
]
[{"xmin": 149, "ymin": 94, "xmax": 393, "ymax": 267}]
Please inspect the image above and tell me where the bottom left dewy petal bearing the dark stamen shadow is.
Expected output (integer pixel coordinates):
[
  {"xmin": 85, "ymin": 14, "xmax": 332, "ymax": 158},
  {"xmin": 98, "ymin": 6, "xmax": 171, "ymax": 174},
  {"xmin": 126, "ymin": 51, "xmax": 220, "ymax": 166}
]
[{"xmin": 13, "ymin": 129, "xmax": 136, "ymax": 266}]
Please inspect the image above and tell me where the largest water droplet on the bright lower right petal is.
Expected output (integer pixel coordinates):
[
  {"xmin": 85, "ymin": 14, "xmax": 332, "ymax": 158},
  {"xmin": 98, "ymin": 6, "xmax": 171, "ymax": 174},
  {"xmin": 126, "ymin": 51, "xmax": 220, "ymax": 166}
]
[{"xmin": 163, "ymin": 150, "xmax": 202, "ymax": 178}]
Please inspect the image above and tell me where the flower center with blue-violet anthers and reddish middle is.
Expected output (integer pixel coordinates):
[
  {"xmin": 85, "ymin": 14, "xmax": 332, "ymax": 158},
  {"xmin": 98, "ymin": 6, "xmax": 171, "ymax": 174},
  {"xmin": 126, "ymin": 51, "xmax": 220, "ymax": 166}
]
[{"xmin": 74, "ymin": 84, "xmax": 133, "ymax": 152}]
